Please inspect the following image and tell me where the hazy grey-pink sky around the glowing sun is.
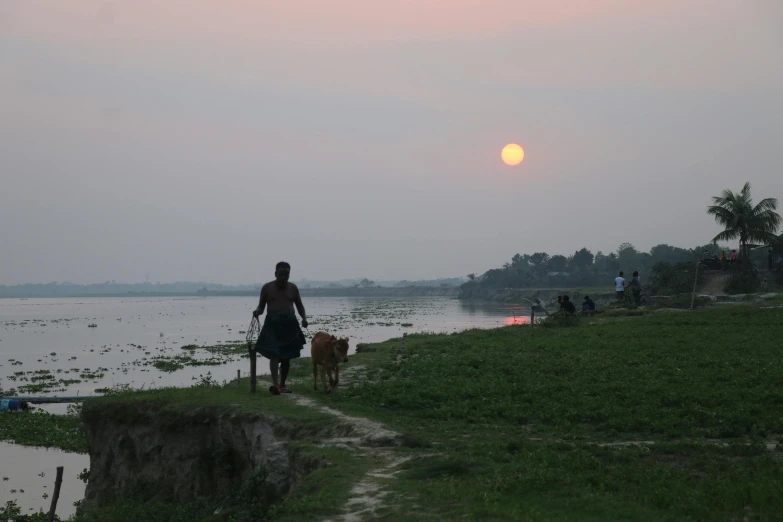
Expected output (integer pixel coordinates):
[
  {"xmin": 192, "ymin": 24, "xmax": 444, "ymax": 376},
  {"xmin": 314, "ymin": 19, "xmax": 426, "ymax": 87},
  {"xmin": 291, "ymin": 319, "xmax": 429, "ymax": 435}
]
[{"xmin": 0, "ymin": 0, "xmax": 783, "ymax": 284}]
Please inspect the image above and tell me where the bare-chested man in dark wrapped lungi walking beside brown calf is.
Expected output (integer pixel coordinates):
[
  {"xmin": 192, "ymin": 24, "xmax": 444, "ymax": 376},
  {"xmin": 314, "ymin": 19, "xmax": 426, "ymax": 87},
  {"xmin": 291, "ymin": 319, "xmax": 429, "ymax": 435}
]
[{"xmin": 253, "ymin": 261, "xmax": 307, "ymax": 395}]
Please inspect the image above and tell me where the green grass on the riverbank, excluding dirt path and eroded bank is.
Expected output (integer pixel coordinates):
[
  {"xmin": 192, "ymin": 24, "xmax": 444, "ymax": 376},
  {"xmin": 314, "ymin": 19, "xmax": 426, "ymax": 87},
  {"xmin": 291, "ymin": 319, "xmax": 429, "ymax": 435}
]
[{"xmin": 7, "ymin": 305, "xmax": 783, "ymax": 522}]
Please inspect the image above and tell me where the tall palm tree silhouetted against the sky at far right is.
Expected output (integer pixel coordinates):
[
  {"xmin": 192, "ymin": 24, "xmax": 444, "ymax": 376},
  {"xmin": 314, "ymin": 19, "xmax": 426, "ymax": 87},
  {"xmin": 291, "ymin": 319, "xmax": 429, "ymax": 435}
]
[{"xmin": 707, "ymin": 182, "xmax": 781, "ymax": 259}]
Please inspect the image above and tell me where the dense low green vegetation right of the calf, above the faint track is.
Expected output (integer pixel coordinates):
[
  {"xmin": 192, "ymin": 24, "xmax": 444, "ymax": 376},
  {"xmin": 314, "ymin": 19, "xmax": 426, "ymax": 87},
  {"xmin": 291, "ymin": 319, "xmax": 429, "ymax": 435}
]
[{"xmin": 332, "ymin": 307, "xmax": 783, "ymax": 438}]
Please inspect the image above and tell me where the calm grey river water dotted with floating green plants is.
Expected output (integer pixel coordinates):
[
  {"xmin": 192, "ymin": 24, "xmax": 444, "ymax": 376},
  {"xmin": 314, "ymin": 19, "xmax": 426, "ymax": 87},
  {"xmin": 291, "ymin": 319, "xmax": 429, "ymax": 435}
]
[{"xmin": 0, "ymin": 297, "xmax": 529, "ymax": 517}]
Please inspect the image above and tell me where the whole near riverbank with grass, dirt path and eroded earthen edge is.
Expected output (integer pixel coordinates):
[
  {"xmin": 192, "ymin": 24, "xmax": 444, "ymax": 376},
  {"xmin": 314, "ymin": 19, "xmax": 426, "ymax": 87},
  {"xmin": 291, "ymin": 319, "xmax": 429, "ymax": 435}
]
[{"xmin": 6, "ymin": 296, "xmax": 783, "ymax": 522}]
